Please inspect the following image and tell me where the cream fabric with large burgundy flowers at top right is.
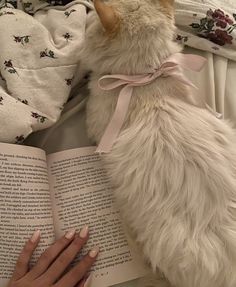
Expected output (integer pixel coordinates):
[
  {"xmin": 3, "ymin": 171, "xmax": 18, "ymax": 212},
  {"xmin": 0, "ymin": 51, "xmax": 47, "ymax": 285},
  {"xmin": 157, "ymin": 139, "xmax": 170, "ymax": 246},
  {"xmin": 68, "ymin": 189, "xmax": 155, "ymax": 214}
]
[{"xmin": 176, "ymin": 0, "xmax": 236, "ymax": 61}]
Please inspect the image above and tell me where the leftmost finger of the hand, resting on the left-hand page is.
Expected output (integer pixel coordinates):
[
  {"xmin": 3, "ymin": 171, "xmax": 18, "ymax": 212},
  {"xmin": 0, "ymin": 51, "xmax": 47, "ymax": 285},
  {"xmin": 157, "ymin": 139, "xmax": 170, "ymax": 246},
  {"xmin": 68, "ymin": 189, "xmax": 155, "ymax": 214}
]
[{"xmin": 12, "ymin": 230, "xmax": 40, "ymax": 280}]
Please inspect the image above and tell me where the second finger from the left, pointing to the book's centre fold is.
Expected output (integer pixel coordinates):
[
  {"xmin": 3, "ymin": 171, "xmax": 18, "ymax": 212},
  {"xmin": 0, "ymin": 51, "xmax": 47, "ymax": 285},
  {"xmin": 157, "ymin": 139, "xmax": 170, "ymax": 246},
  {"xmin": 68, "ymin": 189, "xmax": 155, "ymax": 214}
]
[{"xmin": 29, "ymin": 230, "xmax": 75, "ymax": 279}]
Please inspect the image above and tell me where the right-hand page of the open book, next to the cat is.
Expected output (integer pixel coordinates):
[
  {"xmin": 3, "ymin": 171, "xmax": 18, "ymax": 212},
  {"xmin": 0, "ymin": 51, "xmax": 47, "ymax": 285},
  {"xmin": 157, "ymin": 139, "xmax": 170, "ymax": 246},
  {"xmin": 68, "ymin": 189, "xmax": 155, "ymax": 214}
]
[{"xmin": 47, "ymin": 147, "xmax": 145, "ymax": 287}]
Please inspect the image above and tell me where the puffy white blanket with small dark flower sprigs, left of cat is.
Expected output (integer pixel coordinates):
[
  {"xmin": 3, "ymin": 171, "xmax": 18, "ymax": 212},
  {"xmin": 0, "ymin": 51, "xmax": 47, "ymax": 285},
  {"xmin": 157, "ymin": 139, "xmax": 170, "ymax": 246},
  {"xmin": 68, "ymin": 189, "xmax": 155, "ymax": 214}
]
[{"xmin": 0, "ymin": 0, "xmax": 92, "ymax": 143}]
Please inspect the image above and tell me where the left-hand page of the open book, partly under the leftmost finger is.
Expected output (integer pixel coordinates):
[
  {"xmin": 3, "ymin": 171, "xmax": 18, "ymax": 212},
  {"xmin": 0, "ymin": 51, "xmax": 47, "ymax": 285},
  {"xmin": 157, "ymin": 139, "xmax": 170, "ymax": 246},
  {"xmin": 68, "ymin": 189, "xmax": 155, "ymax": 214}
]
[{"xmin": 0, "ymin": 143, "xmax": 55, "ymax": 287}]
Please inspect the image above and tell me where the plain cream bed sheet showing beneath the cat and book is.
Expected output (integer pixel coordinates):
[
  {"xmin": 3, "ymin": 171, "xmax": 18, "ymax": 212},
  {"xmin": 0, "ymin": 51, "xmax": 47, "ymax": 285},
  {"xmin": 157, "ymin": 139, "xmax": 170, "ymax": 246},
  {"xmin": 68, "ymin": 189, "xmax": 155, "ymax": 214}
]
[{"xmin": 25, "ymin": 47, "xmax": 236, "ymax": 287}]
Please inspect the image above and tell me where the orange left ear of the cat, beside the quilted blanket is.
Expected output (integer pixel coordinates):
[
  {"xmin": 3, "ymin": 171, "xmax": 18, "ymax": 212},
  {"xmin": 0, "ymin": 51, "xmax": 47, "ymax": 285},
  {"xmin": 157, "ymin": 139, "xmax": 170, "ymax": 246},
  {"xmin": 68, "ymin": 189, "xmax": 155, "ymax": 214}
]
[{"xmin": 94, "ymin": 0, "xmax": 119, "ymax": 33}]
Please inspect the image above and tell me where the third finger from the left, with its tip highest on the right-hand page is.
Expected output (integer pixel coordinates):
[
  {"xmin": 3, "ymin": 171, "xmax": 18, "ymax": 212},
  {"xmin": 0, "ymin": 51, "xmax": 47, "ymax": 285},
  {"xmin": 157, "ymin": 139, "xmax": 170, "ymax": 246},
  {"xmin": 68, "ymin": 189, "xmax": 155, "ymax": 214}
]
[{"xmin": 42, "ymin": 226, "xmax": 88, "ymax": 286}]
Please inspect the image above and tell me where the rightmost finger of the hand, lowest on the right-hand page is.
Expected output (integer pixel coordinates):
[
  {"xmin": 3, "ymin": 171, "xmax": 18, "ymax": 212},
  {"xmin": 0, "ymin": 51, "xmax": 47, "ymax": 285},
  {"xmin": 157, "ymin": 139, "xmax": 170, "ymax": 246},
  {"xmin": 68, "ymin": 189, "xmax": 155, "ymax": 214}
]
[{"xmin": 54, "ymin": 247, "xmax": 99, "ymax": 287}]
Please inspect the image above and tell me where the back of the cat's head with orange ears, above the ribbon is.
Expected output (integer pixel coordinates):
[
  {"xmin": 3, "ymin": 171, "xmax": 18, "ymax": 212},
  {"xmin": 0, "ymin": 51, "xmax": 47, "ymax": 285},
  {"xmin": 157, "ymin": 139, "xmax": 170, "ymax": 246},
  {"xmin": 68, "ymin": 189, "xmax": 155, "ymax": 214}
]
[{"xmin": 86, "ymin": 0, "xmax": 178, "ymax": 73}]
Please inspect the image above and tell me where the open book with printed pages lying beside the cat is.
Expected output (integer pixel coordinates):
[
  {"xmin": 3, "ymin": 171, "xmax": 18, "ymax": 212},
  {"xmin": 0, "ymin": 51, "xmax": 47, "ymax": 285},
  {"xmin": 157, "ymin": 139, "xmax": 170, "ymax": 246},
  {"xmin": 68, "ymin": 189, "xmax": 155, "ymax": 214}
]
[{"xmin": 0, "ymin": 143, "xmax": 145, "ymax": 287}]
